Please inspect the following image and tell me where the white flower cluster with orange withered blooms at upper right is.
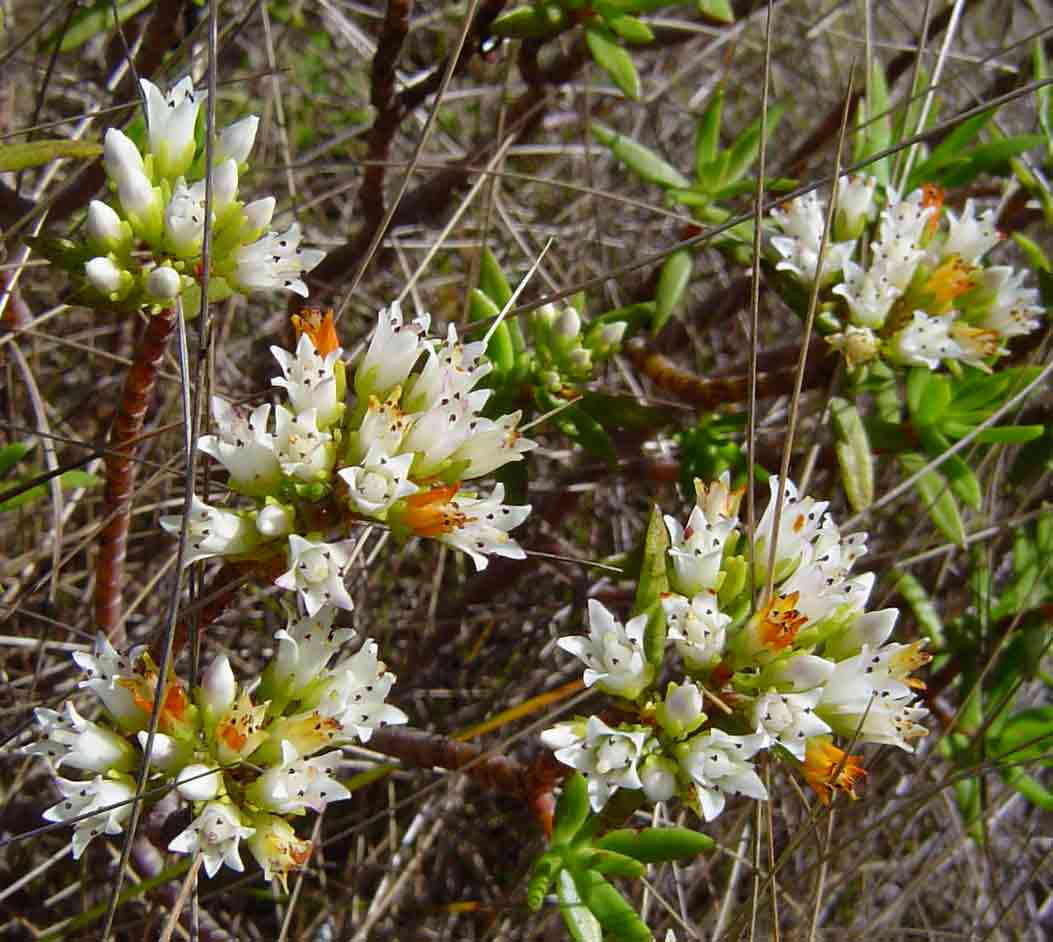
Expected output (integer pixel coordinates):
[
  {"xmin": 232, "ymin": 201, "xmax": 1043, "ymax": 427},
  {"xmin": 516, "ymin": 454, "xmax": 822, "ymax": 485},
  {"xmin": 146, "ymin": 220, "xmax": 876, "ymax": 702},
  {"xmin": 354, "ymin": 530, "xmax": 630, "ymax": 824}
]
[{"xmin": 771, "ymin": 177, "xmax": 1042, "ymax": 370}]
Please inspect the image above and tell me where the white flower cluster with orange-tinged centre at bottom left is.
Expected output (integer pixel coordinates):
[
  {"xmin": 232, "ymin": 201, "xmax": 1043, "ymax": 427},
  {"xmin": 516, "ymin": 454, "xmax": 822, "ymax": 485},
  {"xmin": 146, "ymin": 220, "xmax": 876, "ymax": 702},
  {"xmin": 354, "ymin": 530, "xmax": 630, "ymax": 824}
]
[{"xmin": 22, "ymin": 607, "xmax": 406, "ymax": 882}]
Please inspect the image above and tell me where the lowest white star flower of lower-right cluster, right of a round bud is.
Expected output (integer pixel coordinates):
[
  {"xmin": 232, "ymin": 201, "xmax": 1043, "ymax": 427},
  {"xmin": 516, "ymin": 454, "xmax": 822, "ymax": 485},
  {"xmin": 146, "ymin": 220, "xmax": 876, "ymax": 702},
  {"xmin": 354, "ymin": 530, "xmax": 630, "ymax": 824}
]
[{"xmin": 677, "ymin": 729, "xmax": 768, "ymax": 821}]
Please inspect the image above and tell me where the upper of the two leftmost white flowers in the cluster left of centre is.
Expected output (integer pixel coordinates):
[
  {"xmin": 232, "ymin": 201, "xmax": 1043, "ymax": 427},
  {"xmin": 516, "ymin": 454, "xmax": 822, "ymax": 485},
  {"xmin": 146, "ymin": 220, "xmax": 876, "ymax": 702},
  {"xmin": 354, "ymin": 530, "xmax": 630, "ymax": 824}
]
[{"xmin": 198, "ymin": 396, "xmax": 282, "ymax": 495}]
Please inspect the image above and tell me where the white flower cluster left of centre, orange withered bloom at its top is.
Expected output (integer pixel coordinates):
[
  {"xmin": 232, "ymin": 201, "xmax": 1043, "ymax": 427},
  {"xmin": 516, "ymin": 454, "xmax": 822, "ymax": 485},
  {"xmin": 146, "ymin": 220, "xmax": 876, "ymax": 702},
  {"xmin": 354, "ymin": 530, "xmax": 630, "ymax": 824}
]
[{"xmin": 161, "ymin": 303, "xmax": 535, "ymax": 615}]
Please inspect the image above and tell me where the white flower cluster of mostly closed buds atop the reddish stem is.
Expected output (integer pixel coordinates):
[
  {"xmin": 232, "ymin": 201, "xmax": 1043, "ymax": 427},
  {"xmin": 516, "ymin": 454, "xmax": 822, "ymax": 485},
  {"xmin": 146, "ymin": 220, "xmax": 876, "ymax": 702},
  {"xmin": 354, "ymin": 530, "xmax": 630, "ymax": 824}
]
[{"xmin": 82, "ymin": 77, "xmax": 324, "ymax": 312}]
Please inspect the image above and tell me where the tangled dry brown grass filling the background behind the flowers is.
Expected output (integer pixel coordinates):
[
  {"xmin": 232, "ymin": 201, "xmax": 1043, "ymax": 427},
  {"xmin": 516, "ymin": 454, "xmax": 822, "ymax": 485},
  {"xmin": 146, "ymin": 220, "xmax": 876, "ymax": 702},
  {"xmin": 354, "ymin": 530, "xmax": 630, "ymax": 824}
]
[{"xmin": 0, "ymin": 0, "xmax": 1053, "ymax": 942}]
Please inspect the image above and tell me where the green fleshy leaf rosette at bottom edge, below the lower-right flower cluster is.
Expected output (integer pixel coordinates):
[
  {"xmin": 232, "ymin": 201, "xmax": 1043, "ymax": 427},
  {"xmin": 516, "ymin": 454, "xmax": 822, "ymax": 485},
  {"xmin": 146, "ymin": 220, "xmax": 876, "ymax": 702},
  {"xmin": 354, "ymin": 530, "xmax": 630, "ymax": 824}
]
[{"xmin": 527, "ymin": 778, "xmax": 714, "ymax": 942}]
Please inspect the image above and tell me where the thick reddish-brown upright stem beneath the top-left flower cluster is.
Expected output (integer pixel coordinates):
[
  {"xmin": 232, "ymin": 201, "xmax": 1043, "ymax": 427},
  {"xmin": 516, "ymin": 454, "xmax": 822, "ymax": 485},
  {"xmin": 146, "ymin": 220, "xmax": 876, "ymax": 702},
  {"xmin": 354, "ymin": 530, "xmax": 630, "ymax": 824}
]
[{"xmin": 95, "ymin": 308, "xmax": 176, "ymax": 636}]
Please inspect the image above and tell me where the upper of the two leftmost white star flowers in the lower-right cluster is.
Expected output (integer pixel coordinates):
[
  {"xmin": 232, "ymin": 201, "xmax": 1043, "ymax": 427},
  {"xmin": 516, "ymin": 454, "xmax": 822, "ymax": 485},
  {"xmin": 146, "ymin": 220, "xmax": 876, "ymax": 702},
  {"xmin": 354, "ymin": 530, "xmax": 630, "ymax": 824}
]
[{"xmin": 556, "ymin": 599, "xmax": 654, "ymax": 700}]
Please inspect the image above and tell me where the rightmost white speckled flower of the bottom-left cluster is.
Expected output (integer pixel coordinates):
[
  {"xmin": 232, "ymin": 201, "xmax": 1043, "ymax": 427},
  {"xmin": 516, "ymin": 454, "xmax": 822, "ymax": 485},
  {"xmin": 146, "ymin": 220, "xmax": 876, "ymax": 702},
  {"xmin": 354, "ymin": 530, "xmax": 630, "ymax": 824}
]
[{"xmin": 305, "ymin": 640, "xmax": 409, "ymax": 742}]
